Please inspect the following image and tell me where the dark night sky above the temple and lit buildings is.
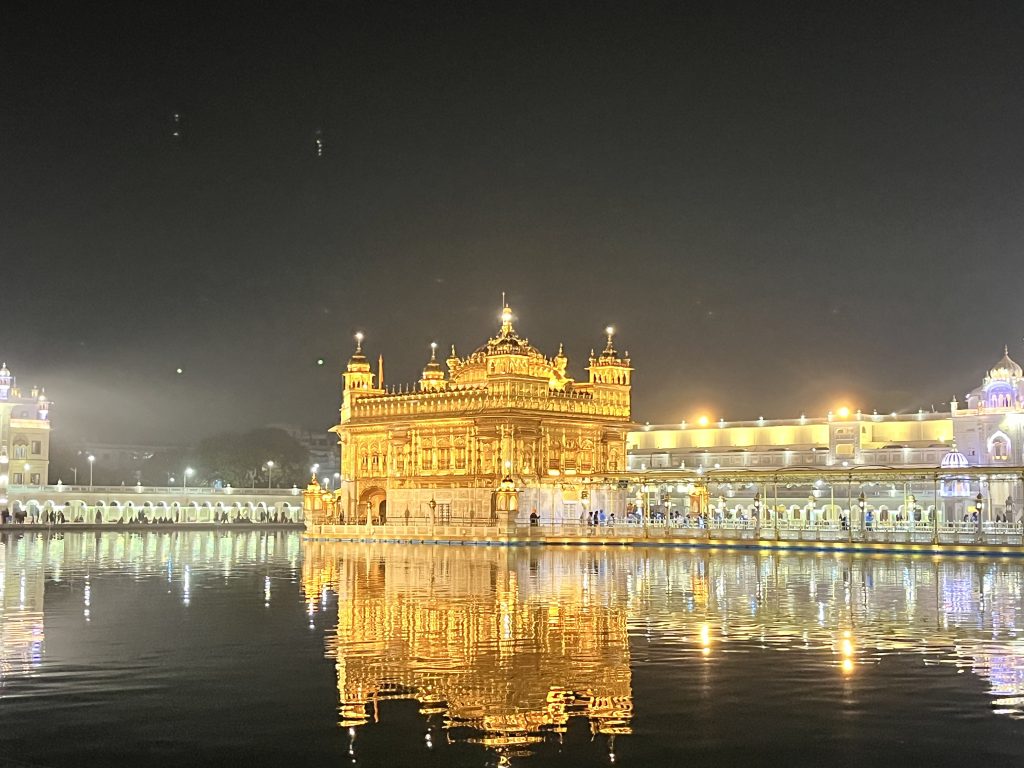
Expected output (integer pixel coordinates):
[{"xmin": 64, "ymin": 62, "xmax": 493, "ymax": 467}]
[{"xmin": 0, "ymin": 1, "xmax": 1024, "ymax": 442}]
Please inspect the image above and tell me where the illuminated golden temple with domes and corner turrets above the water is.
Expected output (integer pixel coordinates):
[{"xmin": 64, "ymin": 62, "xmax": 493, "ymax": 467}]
[{"xmin": 317, "ymin": 305, "xmax": 633, "ymax": 524}]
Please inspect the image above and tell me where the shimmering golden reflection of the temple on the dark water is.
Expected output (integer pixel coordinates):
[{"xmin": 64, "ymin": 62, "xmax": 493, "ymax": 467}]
[{"xmin": 303, "ymin": 544, "xmax": 633, "ymax": 751}]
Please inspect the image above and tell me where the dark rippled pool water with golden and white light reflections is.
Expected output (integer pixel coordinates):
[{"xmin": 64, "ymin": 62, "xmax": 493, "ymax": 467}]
[{"xmin": 0, "ymin": 531, "xmax": 1024, "ymax": 768}]
